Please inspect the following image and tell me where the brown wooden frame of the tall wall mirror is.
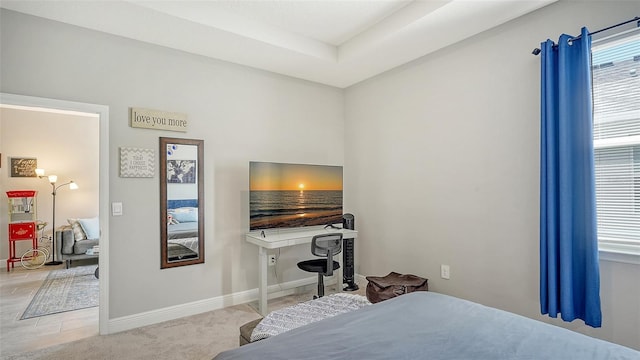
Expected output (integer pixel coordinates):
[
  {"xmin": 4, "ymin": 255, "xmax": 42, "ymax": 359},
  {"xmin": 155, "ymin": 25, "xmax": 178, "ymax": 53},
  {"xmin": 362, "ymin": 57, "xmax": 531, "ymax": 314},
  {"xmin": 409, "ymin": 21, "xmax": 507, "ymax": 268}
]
[{"xmin": 159, "ymin": 137, "xmax": 205, "ymax": 269}]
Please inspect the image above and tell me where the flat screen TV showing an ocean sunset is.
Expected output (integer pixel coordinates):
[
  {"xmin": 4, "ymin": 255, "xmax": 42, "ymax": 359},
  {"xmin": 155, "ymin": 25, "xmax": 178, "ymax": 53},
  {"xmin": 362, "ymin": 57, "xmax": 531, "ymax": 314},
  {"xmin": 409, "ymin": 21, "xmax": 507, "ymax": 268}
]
[{"xmin": 249, "ymin": 161, "xmax": 342, "ymax": 230}]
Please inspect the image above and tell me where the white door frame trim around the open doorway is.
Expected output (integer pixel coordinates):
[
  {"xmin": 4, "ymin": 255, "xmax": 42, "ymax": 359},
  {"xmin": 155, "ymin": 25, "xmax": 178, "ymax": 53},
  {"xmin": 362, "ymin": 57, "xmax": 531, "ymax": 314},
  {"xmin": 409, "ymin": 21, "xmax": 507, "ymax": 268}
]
[{"xmin": 0, "ymin": 93, "xmax": 109, "ymax": 335}]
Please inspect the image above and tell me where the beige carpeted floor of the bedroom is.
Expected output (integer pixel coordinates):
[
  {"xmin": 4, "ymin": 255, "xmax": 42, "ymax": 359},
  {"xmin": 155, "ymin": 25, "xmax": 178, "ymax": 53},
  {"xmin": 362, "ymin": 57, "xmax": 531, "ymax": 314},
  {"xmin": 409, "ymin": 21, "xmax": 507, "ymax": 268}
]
[{"xmin": 7, "ymin": 285, "xmax": 364, "ymax": 360}]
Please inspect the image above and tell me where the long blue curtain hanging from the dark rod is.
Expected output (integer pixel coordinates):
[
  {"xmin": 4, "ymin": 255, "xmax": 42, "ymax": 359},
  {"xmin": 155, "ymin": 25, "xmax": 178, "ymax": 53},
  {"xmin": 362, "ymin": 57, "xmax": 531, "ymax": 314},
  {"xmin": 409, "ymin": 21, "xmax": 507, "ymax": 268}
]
[{"xmin": 540, "ymin": 28, "xmax": 602, "ymax": 327}]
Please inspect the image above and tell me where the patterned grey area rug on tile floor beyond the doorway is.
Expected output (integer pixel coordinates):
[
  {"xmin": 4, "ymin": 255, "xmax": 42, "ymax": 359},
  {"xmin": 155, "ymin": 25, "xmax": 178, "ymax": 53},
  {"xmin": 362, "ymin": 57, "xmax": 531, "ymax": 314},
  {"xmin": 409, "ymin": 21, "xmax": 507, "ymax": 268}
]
[{"xmin": 20, "ymin": 266, "xmax": 100, "ymax": 320}]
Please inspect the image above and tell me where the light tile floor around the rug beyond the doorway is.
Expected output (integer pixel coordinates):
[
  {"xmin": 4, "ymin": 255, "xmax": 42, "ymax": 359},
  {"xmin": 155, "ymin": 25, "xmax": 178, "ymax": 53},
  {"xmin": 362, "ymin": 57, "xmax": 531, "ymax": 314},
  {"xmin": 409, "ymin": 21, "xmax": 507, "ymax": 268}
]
[{"xmin": 0, "ymin": 262, "xmax": 98, "ymax": 358}]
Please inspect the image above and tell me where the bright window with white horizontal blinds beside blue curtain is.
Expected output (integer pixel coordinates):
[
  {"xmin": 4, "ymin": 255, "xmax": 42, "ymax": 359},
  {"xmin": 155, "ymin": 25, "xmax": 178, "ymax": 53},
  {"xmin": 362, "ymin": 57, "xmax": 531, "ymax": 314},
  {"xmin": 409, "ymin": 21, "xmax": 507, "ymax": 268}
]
[{"xmin": 592, "ymin": 29, "xmax": 640, "ymax": 255}]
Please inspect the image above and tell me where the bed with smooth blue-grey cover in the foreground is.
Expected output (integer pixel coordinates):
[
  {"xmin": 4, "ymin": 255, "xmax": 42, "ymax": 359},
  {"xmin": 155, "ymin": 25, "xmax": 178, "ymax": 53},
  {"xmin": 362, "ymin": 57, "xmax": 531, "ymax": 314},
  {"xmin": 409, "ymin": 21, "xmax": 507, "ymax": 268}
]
[{"xmin": 214, "ymin": 291, "xmax": 640, "ymax": 360}]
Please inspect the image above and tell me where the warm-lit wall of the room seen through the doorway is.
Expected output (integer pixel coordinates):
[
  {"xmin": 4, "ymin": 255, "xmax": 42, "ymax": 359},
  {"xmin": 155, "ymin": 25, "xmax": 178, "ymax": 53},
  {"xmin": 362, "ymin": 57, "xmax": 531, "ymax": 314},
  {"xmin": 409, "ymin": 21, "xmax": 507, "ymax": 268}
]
[{"xmin": 0, "ymin": 108, "xmax": 99, "ymax": 258}]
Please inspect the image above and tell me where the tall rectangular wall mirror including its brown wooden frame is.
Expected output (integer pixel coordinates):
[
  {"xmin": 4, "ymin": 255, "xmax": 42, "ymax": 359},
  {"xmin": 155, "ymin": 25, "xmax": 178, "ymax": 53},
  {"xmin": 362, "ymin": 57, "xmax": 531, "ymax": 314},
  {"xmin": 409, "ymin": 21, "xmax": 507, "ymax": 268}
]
[{"xmin": 160, "ymin": 137, "xmax": 204, "ymax": 269}]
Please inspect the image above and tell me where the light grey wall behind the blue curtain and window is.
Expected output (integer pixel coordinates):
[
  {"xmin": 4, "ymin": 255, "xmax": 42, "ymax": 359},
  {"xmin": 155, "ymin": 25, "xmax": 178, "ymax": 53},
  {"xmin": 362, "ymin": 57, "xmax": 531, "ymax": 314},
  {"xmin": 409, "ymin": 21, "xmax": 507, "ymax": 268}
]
[{"xmin": 345, "ymin": 1, "xmax": 640, "ymax": 349}]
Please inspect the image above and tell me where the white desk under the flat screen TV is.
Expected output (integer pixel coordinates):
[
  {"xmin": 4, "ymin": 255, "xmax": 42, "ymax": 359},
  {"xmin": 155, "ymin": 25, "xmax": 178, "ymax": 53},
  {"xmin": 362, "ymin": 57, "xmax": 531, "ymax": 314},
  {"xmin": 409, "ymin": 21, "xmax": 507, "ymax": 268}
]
[{"xmin": 246, "ymin": 227, "xmax": 358, "ymax": 316}]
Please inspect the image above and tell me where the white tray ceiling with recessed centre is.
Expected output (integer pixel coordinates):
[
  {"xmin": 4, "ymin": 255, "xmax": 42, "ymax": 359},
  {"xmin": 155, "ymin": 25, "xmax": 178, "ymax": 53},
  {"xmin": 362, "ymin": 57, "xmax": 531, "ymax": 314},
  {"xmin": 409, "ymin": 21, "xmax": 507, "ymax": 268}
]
[{"xmin": 0, "ymin": 0, "xmax": 556, "ymax": 88}]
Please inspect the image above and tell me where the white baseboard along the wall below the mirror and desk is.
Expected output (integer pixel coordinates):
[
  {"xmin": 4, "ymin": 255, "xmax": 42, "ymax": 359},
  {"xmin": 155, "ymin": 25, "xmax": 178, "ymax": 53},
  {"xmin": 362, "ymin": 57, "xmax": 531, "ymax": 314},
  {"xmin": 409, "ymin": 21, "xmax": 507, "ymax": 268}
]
[{"xmin": 108, "ymin": 277, "xmax": 324, "ymax": 334}]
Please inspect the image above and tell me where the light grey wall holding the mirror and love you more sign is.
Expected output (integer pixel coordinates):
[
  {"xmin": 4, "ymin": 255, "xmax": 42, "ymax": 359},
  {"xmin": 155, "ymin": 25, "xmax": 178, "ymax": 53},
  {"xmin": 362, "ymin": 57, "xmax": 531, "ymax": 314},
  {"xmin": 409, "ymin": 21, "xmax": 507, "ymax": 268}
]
[{"xmin": 0, "ymin": 9, "xmax": 344, "ymax": 319}]
